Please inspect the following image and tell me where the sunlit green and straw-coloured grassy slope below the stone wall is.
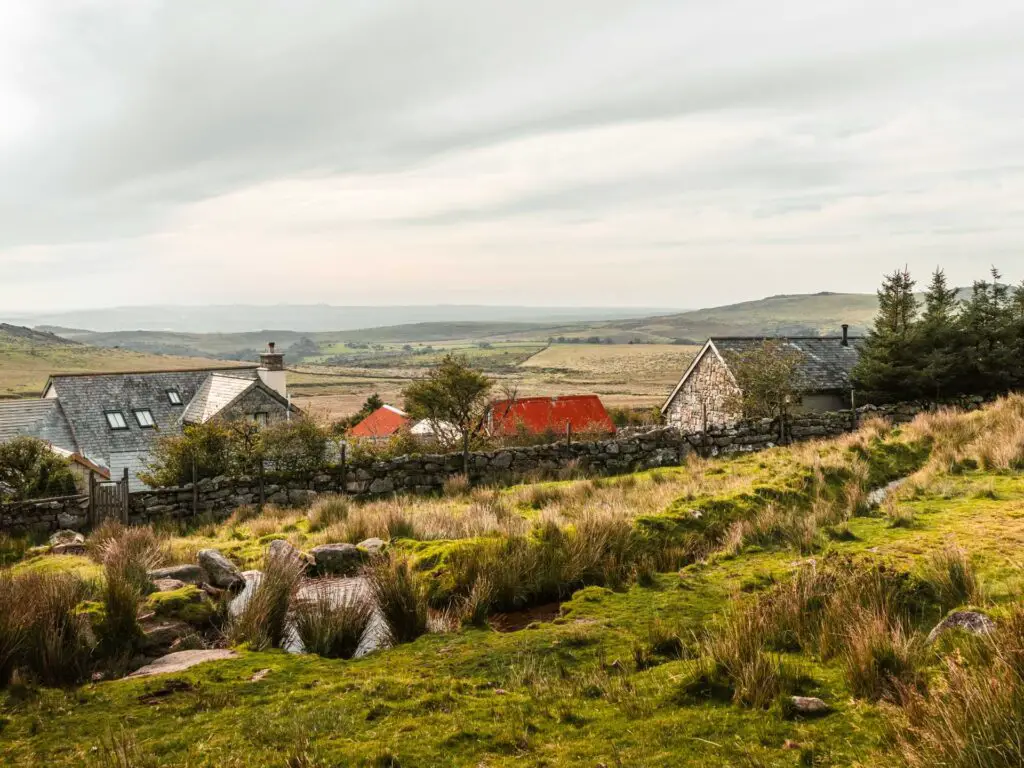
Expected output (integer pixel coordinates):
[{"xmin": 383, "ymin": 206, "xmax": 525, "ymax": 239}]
[{"xmin": 0, "ymin": 398, "xmax": 1024, "ymax": 768}]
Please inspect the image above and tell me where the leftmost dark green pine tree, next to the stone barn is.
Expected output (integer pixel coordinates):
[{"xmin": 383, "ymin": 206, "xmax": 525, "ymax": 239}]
[{"xmin": 853, "ymin": 267, "xmax": 930, "ymax": 400}]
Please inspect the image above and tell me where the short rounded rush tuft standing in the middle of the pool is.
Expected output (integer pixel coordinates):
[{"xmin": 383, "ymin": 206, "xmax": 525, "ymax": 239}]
[{"xmin": 294, "ymin": 583, "xmax": 374, "ymax": 658}]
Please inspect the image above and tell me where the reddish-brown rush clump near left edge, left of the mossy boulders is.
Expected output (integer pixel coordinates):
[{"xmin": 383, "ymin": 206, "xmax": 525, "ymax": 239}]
[{"xmin": 14, "ymin": 571, "xmax": 90, "ymax": 685}]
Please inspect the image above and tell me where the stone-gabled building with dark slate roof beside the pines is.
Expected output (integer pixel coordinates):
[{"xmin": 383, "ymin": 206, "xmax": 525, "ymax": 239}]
[{"xmin": 662, "ymin": 326, "xmax": 863, "ymax": 433}]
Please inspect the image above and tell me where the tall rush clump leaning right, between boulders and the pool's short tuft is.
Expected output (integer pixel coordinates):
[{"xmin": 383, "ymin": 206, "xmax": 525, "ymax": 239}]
[{"xmin": 229, "ymin": 552, "xmax": 306, "ymax": 650}]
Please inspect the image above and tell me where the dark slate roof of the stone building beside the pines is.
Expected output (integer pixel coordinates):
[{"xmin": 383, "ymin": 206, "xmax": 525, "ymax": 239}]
[{"xmin": 711, "ymin": 336, "xmax": 864, "ymax": 392}]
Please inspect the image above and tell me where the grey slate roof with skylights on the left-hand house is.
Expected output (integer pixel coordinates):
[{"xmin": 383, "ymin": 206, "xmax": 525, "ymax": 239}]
[{"xmin": 44, "ymin": 366, "xmax": 257, "ymax": 459}]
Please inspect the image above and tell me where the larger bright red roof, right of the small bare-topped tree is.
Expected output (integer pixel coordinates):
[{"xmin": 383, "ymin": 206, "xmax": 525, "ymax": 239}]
[{"xmin": 490, "ymin": 394, "xmax": 615, "ymax": 435}]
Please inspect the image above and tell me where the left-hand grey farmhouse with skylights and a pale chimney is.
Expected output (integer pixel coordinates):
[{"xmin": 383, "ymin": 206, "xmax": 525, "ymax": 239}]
[{"xmin": 0, "ymin": 343, "xmax": 298, "ymax": 490}]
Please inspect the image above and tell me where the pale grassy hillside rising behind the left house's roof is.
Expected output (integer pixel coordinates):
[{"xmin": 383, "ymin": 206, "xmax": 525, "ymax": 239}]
[{"xmin": 0, "ymin": 326, "xmax": 249, "ymax": 397}]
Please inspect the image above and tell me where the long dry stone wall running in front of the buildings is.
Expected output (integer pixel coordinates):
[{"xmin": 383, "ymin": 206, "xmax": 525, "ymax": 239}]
[{"xmin": 0, "ymin": 398, "xmax": 982, "ymax": 534}]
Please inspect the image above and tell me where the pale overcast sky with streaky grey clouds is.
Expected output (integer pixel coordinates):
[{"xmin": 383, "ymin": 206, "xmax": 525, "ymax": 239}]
[{"xmin": 0, "ymin": 0, "xmax": 1024, "ymax": 313}]
